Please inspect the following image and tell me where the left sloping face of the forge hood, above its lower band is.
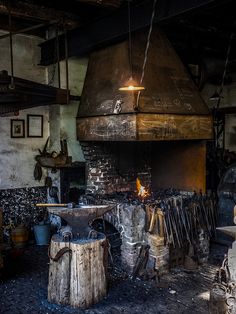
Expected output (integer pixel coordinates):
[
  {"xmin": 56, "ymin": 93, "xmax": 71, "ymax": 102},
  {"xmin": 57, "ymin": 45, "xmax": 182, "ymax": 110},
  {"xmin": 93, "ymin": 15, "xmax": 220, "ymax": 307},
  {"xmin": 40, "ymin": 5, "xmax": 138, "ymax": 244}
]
[{"xmin": 78, "ymin": 42, "xmax": 134, "ymax": 117}]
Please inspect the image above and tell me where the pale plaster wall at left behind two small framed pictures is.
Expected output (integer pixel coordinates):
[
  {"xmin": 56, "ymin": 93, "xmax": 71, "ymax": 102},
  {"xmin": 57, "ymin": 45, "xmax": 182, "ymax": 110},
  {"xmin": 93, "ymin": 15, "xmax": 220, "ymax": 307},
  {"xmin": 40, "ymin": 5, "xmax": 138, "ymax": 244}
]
[{"xmin": 0, "ymin": 32, "xmax": 49, "ymax": 189}]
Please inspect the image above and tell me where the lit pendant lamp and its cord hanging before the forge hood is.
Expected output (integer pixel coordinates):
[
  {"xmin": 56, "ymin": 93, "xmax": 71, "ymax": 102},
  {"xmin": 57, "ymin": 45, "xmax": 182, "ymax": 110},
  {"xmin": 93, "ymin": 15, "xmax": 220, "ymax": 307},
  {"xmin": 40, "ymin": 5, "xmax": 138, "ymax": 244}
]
[{"xmin": 119, "ymin": 0, "xmax": 145, "ymax": 91}]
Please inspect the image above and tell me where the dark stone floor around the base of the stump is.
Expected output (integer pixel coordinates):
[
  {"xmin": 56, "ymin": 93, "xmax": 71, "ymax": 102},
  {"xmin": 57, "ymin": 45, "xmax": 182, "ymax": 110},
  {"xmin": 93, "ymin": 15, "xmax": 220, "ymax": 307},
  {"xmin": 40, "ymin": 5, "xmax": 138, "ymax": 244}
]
[{"xmin": 0, "ymin": 245, "xmax": 229, "ymax": 314}]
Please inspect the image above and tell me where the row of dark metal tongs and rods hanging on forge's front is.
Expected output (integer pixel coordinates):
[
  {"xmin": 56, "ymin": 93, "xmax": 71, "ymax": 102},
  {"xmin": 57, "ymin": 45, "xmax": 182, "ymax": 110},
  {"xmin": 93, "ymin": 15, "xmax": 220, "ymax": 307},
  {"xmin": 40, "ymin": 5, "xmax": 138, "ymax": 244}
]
[{"xmin": 146, "ymin": 194, "xmax": 217, "ymax": 248}]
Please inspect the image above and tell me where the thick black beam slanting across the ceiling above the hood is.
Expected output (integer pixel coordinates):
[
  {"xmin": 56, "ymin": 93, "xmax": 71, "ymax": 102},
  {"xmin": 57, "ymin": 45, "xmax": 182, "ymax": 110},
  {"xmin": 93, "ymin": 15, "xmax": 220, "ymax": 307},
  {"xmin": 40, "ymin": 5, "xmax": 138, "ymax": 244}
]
[{"xmin": 40, "ymin": 0, "xmax": 219, "ymax": 66}]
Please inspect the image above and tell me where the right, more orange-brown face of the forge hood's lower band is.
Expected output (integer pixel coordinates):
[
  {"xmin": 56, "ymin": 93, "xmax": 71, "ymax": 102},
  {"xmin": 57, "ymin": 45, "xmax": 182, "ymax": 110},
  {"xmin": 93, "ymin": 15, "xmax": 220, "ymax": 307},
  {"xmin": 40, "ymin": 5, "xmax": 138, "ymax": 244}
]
[{"xmin": 137, "ymin": 114, "xmax": 213, "ymax": 141}]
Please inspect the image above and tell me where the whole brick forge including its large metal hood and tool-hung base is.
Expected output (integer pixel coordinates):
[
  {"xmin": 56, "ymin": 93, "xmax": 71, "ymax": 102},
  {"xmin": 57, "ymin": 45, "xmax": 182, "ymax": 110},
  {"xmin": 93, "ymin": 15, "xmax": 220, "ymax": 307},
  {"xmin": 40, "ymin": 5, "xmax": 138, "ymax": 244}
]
[{"xmin": 77, "ymin": 26, "xmax": 214, "ymax": 273}]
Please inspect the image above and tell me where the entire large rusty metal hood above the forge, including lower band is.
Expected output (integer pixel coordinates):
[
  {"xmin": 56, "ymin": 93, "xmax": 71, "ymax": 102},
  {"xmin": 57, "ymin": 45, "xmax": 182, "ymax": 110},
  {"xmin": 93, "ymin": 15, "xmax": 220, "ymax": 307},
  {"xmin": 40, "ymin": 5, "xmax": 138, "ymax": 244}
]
[{"xmin": 77, "ymin": 27, "xmax": 212, "ymax": 141}]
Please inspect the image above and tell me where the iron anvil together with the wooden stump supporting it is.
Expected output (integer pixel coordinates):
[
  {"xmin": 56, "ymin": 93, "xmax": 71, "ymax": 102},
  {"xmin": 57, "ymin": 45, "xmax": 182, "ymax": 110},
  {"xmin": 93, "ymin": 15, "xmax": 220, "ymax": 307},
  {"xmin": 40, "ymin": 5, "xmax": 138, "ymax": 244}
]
[{"xmin": 48, "ymin": 205, "xmax": 114, "ymax": 309}]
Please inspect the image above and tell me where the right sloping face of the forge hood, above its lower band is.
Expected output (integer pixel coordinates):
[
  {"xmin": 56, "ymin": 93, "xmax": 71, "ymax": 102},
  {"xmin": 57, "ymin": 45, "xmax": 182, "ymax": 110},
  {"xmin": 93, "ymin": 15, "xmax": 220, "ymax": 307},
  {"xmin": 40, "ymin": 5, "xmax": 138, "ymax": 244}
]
[{"xmin": 133, "ymin": 28, "xmax": 209, "ymax": 114}]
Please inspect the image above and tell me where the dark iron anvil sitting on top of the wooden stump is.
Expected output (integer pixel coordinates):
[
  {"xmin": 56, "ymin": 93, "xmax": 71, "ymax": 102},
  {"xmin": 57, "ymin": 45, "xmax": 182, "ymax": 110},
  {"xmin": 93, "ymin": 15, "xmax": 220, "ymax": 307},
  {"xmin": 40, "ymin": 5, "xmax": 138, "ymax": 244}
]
[{"xmin": 47, "ymin": 205, "xmax": 114, "ymax": 238}]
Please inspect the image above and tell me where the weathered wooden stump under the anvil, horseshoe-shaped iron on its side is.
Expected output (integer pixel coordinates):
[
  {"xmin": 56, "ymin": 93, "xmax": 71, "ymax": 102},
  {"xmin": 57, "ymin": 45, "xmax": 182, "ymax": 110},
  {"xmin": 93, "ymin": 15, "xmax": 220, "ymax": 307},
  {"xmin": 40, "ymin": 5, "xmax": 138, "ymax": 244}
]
[{"xmin": 48, "ymin": 234, "xmax": 107, "ymax": 309}]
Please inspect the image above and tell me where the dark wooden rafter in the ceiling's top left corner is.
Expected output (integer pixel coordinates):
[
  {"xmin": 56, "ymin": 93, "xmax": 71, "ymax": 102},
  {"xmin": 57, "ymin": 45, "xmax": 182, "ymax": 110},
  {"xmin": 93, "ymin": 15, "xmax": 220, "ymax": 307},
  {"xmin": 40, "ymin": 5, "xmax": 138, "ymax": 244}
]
[{"xmin": 0, "ymin": 1, "xmax": 78, "ymax": 28}]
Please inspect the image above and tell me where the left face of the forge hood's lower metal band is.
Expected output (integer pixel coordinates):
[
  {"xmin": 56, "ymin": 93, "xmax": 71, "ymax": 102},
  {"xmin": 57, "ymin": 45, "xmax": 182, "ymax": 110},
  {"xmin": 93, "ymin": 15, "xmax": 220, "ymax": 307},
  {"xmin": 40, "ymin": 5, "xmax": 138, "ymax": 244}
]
[{"xmin": 77, "ymin": 114, "xmax": 136, "ymax": 141}]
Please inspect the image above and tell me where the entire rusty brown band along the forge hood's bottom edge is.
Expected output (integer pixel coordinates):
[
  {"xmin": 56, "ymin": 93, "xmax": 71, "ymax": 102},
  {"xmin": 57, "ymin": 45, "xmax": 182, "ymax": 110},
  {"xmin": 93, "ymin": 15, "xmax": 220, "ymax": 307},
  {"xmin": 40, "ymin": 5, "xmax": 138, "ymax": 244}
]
[{"xmin": 77, "ymin": 113, "xmax": 213, "ymax": 141}]
